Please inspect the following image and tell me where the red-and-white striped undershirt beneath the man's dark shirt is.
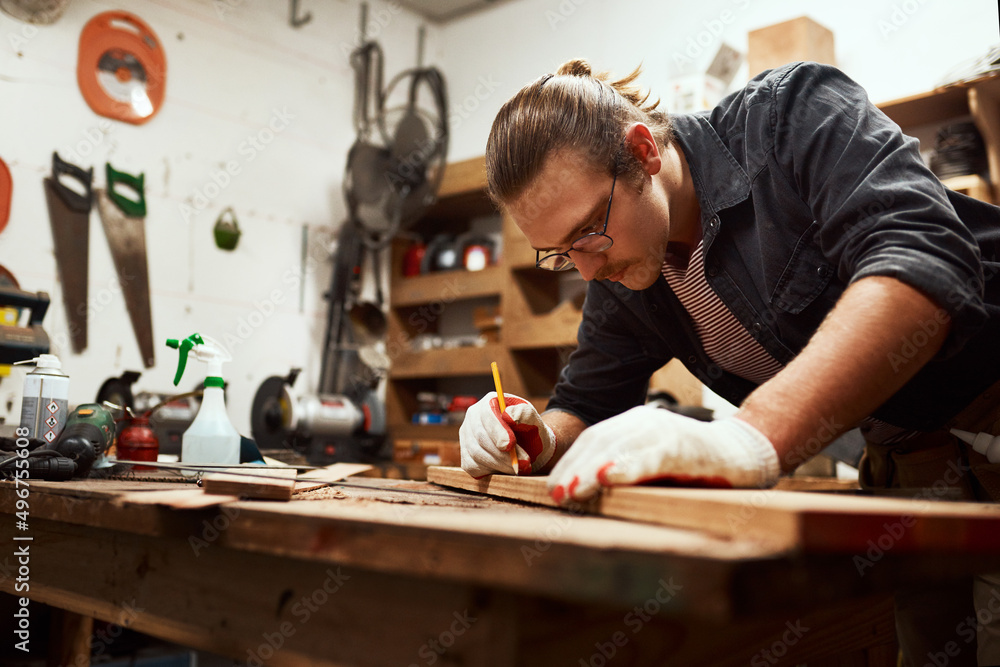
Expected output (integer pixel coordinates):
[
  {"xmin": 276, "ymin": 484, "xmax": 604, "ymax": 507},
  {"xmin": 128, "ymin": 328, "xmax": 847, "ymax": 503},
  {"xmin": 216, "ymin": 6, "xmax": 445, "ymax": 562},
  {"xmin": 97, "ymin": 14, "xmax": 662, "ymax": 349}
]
[{"xmin": 660, "ymin": 241, "xmax": 918, "ymax": 443}]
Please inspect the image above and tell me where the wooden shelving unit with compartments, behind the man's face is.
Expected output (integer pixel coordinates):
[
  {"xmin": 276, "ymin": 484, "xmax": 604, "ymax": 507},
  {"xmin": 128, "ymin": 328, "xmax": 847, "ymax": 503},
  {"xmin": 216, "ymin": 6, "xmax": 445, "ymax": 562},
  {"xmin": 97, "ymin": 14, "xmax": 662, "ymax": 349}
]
[{"xmin": 386, "ymin": 158, "xmax": 701, "ymax": 464}]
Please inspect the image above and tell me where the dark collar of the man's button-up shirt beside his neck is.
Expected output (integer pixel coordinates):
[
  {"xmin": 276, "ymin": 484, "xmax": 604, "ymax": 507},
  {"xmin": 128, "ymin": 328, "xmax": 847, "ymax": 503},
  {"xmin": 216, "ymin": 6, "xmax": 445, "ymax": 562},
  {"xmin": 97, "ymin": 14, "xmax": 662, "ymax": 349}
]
[{"xmin": 670, "ymin": 114, "xmax": 750, "ymax": 221}]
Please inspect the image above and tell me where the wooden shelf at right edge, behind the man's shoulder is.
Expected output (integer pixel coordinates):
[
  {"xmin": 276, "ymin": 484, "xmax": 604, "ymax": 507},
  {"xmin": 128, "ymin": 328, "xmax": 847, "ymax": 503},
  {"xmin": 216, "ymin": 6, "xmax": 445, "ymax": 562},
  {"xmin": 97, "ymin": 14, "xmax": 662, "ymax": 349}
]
[{"xmin": 878, "ymin": 75, "xmax": 1000, "ymax": 204}]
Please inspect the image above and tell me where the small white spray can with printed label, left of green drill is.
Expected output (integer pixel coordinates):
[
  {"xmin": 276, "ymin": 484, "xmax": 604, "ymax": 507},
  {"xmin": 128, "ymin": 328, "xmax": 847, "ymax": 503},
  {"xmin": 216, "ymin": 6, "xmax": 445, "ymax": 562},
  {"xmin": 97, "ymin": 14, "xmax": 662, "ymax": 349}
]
[{"xmin": 17, "ymin": 354, "xmax": 69, "ymax": 445}]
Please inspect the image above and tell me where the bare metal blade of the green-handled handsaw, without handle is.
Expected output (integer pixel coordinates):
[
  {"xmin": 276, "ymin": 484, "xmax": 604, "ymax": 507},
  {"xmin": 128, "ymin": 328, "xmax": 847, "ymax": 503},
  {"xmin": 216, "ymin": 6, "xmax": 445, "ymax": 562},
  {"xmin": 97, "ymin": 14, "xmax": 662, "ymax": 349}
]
[{"xmin": 94, "ymin": 189, "xmax": 155, "ymax": 368}]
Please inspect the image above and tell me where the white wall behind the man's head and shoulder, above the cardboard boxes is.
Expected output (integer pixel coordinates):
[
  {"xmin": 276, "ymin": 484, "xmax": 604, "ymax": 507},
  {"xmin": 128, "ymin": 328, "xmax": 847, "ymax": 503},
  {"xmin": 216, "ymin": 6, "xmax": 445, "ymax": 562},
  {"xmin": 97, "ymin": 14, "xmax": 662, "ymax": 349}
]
[{"xmin": 438, "ymin": 0, "xmax": 1000, "ymax": 159}]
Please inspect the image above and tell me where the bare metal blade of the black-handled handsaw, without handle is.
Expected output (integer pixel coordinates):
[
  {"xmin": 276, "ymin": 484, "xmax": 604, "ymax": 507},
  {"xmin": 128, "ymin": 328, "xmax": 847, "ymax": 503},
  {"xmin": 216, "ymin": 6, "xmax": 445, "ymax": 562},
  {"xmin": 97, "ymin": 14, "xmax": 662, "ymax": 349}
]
[{"xmin": 44, "ymin": 178, "xmax": 90, "ymax": 354}]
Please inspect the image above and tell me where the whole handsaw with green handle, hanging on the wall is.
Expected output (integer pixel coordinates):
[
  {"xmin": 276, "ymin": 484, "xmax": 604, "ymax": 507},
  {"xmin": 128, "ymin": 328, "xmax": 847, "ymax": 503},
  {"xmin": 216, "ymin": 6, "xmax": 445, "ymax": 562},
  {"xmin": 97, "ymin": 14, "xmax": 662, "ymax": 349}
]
[{"xmin": 94, "ymin": 162, "xmax": 155, "ymax": 368}]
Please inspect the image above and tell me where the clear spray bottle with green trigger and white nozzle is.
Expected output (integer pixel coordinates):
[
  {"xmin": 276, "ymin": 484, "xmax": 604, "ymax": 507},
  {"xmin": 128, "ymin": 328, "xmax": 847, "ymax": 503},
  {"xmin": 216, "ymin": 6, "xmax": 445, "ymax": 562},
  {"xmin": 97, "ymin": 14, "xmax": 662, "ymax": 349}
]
[{"xmin": 167, "ymin": 334, "xmax": 240, "ymax": 465}]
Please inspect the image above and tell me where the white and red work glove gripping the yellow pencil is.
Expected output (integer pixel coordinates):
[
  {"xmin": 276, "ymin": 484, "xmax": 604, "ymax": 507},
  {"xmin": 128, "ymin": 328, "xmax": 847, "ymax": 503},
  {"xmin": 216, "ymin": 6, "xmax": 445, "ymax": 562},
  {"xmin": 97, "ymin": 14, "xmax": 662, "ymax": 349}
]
[{"xmin": 458, "ymin": 391, "xmax": 556, "ymax": 479}]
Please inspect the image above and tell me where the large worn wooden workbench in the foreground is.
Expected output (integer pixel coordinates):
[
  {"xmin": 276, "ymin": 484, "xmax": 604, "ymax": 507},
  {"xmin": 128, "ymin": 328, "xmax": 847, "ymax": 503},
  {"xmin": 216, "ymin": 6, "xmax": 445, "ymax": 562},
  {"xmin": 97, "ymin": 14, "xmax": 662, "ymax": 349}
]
[{"xmin": 0, "ymin": 478, "xmax": 1000, "ymax": 667}]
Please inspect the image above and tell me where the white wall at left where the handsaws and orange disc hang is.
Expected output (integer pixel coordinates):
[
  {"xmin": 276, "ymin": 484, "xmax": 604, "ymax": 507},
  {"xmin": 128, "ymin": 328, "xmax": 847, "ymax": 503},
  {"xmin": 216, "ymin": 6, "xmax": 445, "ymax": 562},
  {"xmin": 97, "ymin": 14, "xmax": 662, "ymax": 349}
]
[{"xmin": 0, "ymin": 0, "xmax": 435, "ymax": 434}]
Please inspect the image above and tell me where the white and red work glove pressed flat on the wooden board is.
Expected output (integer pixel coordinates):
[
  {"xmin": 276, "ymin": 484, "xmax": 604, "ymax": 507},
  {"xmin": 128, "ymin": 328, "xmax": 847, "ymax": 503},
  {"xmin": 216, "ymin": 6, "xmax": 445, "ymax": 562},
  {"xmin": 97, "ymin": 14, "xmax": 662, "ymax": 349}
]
[{"xmin": 548, "ymin": 406, "xmax": 780, "ymax": 503}]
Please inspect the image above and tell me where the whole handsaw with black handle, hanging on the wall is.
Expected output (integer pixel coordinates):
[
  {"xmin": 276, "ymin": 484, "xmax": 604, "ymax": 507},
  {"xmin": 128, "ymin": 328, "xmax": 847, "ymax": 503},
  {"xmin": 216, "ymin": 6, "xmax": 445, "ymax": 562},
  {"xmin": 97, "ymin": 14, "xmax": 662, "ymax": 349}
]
[{"xmin": 43, "ymin": 153, "xmax": 94, "ymax": 354}]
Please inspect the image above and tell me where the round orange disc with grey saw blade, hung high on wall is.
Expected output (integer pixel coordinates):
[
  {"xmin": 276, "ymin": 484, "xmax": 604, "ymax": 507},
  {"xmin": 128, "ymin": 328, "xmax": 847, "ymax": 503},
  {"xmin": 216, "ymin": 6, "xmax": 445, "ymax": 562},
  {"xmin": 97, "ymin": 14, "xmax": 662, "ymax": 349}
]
[{"xmin": 76, "ymin": 11, "xmax": 167, "ymax": 125}]
